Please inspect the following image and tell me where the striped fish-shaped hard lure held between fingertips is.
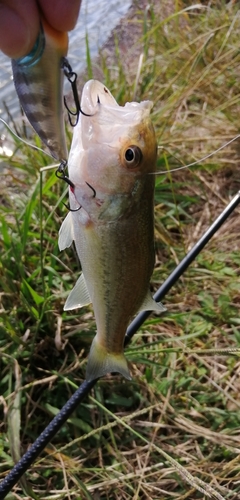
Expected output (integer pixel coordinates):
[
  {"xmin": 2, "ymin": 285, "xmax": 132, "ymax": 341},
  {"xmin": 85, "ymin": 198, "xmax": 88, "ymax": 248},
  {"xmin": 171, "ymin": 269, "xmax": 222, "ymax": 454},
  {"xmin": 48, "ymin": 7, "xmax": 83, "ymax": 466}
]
[{"xmin": 12, "ymin": 19, "xmax": 68, "ymax": 161}]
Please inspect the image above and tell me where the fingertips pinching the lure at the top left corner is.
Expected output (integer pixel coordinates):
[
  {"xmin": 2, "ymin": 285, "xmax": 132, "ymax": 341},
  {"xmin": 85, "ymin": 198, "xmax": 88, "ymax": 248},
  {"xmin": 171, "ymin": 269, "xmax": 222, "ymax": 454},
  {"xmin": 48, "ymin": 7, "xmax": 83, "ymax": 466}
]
[{"xmin": 0, "ymin": 0, "xmax": 81, "ymax": 59}]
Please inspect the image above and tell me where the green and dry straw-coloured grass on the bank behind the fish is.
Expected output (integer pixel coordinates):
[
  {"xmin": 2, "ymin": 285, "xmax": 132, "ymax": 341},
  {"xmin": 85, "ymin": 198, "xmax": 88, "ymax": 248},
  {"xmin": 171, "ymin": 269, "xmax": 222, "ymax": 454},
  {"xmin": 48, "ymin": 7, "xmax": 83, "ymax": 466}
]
[{"xmin": 0, "ymin": 0, "xmax": 240, "ymax": 500}]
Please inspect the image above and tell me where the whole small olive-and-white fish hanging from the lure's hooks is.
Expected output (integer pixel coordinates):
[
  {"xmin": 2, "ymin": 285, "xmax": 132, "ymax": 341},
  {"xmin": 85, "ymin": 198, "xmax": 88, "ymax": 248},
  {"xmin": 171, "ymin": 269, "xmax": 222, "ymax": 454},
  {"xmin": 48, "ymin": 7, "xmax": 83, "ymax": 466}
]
[{"xmin": 59, "ymin": 80, "xmax": 165, "ymax": 381}]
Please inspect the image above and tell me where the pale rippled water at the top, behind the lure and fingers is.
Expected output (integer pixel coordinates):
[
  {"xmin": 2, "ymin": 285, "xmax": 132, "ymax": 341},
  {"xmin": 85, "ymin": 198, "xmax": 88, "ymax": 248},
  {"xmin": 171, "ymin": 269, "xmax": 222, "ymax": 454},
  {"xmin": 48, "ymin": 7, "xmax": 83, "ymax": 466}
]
[{"xmin": 0, "ymin": 0, "xmax": 131, "ymax": 130}]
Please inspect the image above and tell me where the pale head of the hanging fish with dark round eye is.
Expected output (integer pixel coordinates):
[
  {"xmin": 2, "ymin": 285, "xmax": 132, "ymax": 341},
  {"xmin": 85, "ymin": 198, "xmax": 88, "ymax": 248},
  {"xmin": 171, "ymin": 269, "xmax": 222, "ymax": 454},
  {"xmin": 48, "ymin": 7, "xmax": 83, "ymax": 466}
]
[{"xmin": 68, "ymin": 80, "xmax": 157, "ymax": 186}]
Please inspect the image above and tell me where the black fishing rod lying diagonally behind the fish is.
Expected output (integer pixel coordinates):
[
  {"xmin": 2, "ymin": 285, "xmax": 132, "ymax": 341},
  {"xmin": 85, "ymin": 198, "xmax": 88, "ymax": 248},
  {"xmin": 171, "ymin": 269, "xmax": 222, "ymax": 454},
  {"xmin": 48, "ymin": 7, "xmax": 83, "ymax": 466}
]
[{"xmin": 0, "ymin": 191, "xmax": 240, "ymax": 500}]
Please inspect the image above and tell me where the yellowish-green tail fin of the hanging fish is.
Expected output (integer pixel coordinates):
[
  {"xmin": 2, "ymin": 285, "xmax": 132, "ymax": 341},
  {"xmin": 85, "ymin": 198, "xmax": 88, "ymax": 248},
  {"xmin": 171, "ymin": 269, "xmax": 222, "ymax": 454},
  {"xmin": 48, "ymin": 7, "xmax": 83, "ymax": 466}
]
[{"xmin": 86, "ymin": 337, "xmax": 132, "ymax": 382}]
